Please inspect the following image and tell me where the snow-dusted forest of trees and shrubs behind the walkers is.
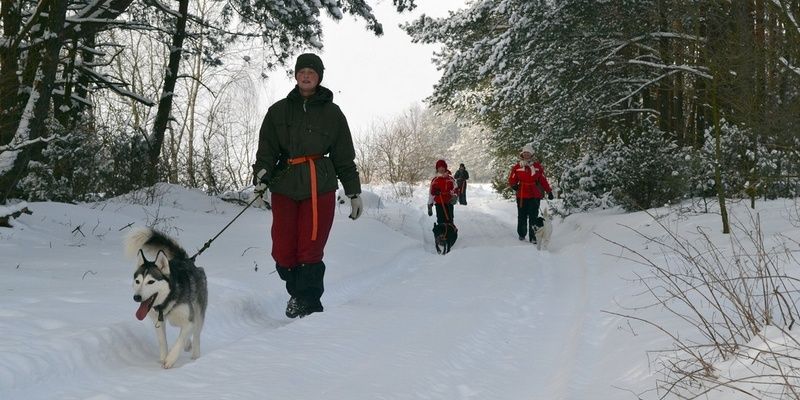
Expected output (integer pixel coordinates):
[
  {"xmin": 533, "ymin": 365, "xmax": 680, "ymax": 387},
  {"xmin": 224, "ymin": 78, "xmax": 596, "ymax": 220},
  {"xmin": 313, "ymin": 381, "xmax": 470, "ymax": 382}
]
[{"xmin": 0, "ymin": 0, "xmax": 800, "ymax": 223}]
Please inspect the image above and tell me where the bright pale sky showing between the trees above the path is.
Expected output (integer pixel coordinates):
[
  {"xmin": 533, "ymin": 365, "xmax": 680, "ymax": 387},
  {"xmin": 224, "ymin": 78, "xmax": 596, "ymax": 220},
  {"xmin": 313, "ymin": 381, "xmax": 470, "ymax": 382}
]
[{"xmin": 267, "ymin": 0, "xmax": 465, "ymax": 135}]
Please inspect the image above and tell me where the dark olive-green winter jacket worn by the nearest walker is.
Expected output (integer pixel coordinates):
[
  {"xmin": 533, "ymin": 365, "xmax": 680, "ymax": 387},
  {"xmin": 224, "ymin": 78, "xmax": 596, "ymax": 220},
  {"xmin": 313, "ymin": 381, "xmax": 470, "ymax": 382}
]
[{"xmin": 253, "ymin": 86, "xmax": 361, "ymax": 200}]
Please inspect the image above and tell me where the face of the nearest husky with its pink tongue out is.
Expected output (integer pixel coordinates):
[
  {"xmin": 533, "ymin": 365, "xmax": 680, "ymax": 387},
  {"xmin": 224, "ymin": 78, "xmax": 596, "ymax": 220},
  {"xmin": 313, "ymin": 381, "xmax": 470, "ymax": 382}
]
[{"xmin": 133, "ymin": 250, "xmax": 169, "ymax": 320}]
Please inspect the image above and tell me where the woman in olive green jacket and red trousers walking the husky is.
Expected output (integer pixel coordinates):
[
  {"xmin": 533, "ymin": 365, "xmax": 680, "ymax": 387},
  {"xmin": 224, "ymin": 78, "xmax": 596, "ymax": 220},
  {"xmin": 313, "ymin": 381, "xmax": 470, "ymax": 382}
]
[{"xmin": 253, "ymin": 53, "xmax": 362, "ymax": 318}]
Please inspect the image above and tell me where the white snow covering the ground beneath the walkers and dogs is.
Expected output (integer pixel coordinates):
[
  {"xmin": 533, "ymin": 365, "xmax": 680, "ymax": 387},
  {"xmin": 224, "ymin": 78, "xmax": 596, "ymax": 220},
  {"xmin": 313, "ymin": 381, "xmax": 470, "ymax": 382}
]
[{"xmin": 0, "ymin": 184, "xmax": 800, "ymax": 400}]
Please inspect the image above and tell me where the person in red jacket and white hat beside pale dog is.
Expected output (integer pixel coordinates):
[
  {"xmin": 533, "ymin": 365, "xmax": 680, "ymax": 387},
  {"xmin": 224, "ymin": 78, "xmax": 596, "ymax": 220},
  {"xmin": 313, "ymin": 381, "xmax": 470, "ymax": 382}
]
[{"xmin": 508, "ymin": 144, "xmax": 553, "ymax": 243}]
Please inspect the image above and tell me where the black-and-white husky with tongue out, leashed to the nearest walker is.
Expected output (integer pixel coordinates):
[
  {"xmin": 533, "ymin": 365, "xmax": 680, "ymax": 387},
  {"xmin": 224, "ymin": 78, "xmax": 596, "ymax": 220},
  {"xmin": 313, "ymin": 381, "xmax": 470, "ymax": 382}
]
[{"xmin": 125, "ymin": 228, "xmax": 208, "ymax": 368}]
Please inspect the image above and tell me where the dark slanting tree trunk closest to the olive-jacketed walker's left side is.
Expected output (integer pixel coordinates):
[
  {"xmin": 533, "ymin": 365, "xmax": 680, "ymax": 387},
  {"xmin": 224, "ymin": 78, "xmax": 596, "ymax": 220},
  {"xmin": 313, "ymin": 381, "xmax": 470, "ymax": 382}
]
[{"xmin": 145, "ymin": 0, "xmax": 189, "ymax": 185}]
